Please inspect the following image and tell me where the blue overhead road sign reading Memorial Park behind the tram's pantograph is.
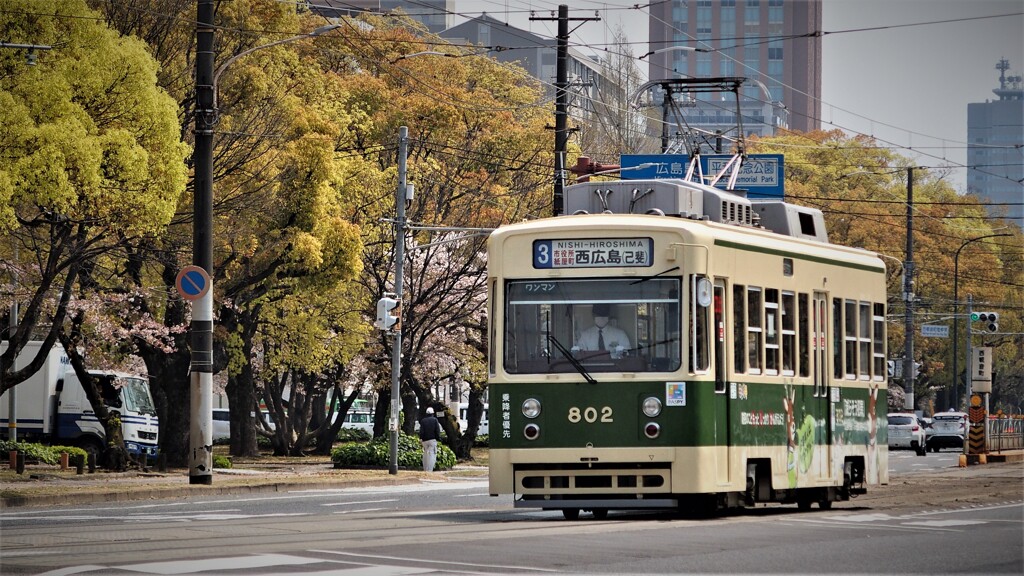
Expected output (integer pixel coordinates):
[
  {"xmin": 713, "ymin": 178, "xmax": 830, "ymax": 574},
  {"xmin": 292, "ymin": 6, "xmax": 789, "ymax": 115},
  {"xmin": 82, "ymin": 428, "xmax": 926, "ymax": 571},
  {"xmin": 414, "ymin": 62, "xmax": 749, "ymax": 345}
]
[{"xmin": 618, "ymin": 154, "xmax": 785, "ymax": 200}]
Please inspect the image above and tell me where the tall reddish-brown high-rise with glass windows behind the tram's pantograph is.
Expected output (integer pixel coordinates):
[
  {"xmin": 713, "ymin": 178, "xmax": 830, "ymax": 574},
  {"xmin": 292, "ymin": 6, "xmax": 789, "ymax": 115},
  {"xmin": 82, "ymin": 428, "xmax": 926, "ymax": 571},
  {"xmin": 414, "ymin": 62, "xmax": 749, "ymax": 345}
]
[{"xmin": 647, "ymin": 0, "xmax": 822, "ymax": 140}]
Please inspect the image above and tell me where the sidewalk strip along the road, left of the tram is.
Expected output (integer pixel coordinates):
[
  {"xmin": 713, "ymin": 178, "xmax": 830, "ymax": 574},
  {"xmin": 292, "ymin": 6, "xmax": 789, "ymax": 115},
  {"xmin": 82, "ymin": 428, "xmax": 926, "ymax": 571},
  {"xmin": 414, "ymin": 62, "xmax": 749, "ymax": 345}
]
[{"xmin": 0, "ymin": 460, "xmax": 487, "ymax": 509}]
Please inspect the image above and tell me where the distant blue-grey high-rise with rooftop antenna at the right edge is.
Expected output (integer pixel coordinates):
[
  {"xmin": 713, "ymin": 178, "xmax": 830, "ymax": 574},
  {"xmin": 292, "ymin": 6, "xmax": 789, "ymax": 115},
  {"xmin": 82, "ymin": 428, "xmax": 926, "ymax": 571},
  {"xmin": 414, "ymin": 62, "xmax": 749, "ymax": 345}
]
[{"xmin": 967, "ymin": 59, "xmax": 1024, "ymax": 228}]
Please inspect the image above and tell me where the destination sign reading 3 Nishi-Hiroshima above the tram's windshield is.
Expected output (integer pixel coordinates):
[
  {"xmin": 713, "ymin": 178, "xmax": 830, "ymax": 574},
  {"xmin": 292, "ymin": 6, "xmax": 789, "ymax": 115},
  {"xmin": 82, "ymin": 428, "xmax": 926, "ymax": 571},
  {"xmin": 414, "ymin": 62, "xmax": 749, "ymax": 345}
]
[{"xmin": 534, "ymin": 238, "xmax": 654, "ymax": 269}]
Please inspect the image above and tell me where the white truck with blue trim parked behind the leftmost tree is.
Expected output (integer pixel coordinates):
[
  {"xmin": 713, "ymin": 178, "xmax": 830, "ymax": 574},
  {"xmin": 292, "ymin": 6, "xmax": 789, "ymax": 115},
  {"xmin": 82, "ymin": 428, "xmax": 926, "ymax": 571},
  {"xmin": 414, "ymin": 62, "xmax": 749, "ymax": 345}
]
[{"xmin": 0, "ymin": 341, "xmax": 160, "ymax": 459}]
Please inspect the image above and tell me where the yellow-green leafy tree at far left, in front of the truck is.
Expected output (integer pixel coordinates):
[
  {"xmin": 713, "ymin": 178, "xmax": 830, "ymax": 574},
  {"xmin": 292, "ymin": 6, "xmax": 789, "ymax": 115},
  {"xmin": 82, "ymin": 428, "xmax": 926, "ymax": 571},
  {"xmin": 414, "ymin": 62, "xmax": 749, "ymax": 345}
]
[{"xmin": 0, "ymin": 0, "xmax": 187, "ymax": 466}]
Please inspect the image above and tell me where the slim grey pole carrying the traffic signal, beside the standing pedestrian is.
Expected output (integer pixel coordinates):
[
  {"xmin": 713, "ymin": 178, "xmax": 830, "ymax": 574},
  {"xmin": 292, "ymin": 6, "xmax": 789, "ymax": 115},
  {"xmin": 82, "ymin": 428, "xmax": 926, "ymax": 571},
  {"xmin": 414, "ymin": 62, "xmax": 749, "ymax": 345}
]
[{"xmin": 388, "ymin": 126, "xmax": 409, "ymax": 475}]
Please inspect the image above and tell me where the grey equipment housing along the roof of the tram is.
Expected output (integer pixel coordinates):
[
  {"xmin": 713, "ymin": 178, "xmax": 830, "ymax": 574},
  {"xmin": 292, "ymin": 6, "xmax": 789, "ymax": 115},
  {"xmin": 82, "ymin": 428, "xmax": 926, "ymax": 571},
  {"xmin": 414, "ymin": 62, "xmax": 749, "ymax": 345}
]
[{"xmin": 563, "ymin": 179, "xmax": 828, "ymax": 243}]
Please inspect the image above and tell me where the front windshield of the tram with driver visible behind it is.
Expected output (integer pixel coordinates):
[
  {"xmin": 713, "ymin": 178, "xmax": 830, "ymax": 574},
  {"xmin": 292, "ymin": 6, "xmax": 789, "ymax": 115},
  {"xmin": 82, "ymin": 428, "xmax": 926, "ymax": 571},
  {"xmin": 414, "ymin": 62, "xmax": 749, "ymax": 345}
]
[{"xmin": 504, "ymin": 278, "xmax": 682, "ymax": 379}]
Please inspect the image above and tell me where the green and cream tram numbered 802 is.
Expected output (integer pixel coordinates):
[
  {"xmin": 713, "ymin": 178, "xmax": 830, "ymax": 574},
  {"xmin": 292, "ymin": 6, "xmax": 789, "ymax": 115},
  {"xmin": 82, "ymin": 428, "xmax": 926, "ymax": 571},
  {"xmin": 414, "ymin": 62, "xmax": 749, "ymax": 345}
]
[{"xmin": 488, "ymin": 180, "xmax": 888, "ymax": 519}]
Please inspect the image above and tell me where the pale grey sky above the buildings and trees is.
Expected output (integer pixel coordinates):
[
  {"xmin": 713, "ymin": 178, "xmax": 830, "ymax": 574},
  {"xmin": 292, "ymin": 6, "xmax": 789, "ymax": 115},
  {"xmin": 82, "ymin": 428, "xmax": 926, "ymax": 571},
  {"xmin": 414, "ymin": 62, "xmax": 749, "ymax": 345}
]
[{"xmin": 455, "ymin": 0, "xmax": 1024, "ymax": 190}]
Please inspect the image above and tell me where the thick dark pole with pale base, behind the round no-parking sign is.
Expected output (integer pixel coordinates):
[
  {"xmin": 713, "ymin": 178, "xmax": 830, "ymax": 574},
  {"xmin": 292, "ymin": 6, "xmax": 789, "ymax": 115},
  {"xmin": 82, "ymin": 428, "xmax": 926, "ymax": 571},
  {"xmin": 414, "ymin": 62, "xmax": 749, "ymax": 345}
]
[{"xmin": 188, "ymin": 0, "xmax": 217, "ymax": 485}]
